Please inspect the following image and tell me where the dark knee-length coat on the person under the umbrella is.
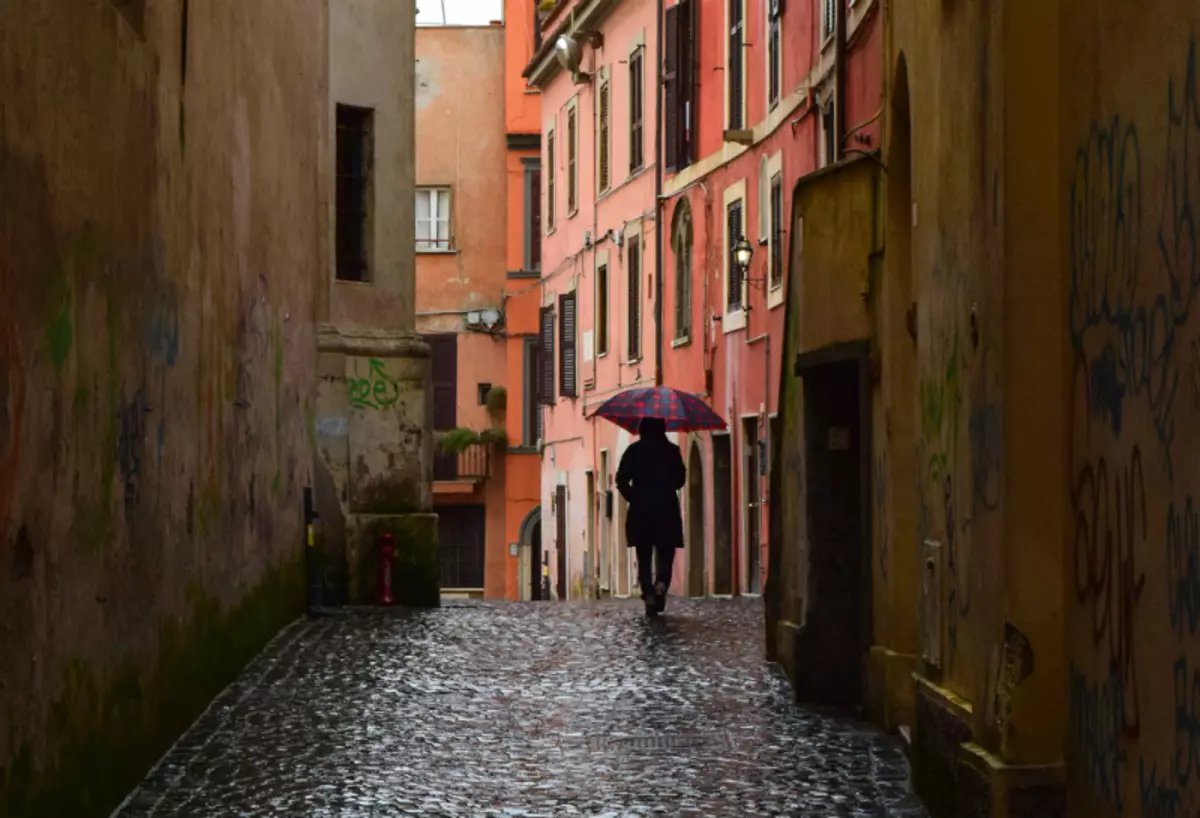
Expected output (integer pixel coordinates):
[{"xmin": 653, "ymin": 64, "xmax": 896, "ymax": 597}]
[{"xmin": 617, "ymin": 426, "xmax": 688, "ymax": 548}]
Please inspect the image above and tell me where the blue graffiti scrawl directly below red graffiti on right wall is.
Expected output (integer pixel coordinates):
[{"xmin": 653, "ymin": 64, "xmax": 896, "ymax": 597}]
[{"xmin": 1068, "ymin": 664, "xmax": 1126, "ymax": 813}]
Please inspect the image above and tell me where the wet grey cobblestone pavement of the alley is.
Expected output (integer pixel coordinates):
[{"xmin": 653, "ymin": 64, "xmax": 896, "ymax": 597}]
[{"xmin": 115, "ymin": 599, "xmax": 925, "ymax": 818}]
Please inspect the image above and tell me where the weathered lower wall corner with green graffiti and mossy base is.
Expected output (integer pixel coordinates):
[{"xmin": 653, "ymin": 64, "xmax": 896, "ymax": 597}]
[{"xmin": 314, "ymin": 324, "xmax": 439, "ymax": 606}]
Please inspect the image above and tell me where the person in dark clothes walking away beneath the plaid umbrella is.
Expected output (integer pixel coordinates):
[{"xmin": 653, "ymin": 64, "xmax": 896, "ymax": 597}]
[{"xmin": 617, "ymin": 417, "xmax": 688, "ymax": 616}]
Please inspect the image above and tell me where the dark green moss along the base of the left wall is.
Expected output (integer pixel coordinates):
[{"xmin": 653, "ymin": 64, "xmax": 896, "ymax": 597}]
[{"xmin": 0, "ymin": 553, "xmax": 304, "ymax": 818}]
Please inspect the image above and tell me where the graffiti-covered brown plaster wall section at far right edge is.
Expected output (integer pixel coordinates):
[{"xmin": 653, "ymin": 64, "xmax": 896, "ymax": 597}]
[{"xmin": 1058, "ymin": 0, "xmax": 1200, "ymax": 818}]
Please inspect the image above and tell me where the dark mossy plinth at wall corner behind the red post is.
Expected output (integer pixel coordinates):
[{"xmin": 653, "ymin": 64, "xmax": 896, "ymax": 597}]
[{"xmin": 356, "ymin": 513, "xmax": 442, "ymax": 608}]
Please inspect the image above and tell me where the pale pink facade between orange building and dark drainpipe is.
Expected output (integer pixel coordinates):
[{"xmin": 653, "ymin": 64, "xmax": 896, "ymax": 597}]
[{"xmin": 527, "ymin": 0, "xmax": 658, "ymax": 599}]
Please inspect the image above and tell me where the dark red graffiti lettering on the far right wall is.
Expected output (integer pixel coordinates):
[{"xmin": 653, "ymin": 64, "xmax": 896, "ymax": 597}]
[{"xmin": 1070, "ymin": 446, "xmax": 1146, "ymax": 738}]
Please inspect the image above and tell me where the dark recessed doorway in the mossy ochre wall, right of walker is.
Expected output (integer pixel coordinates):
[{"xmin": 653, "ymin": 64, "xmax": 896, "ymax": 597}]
[{"xmin": 796, "ymin": 343, "xmax": 871, "ymax": 706}]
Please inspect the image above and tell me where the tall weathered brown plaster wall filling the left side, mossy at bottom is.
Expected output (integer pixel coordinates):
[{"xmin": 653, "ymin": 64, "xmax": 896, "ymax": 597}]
[{"xmin": 0, "ymin": 0, "xmax": 325, "ymax": 816}]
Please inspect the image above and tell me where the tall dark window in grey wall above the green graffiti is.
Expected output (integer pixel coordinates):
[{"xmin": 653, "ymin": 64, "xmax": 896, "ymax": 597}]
[{"xmin": 335, "ymin": 106, "xmax": 374, "ymax": 281}]
